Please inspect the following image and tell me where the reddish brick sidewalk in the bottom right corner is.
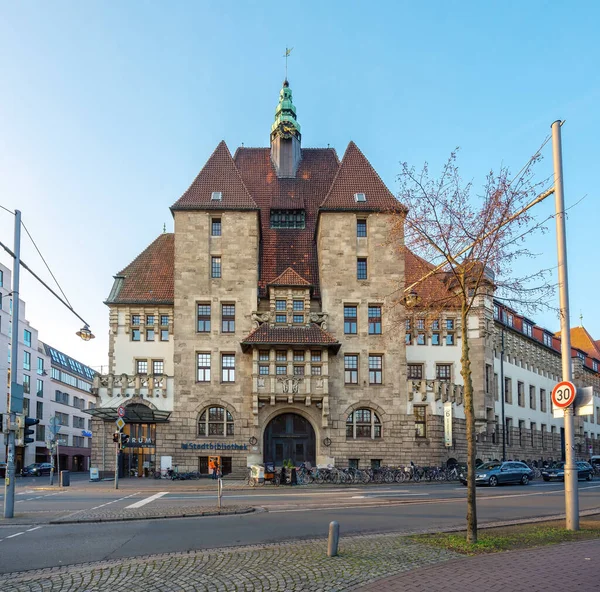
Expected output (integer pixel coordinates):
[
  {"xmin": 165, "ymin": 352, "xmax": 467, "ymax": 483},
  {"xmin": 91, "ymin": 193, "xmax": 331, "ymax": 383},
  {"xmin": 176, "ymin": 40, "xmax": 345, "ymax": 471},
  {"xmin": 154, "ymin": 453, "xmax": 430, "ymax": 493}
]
[{"xmin": 356, "ymin": 539, "xmax": 600, "ymax": 592}]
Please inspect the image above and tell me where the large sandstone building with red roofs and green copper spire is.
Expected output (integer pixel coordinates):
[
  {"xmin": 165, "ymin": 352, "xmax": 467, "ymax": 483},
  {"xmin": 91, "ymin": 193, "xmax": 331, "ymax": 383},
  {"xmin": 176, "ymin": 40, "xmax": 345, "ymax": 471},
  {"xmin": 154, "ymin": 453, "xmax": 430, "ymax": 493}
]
[{"xmin": 92, "ymin": 81, "xmax": 599, "ymax": 476}]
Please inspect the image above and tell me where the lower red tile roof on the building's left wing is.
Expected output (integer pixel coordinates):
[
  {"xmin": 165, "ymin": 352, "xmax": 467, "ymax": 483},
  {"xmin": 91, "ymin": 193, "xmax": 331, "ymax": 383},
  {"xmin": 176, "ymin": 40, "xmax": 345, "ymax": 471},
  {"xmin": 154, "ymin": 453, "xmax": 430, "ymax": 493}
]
[{"xmin": 106, "ymin": 233, "xmax": 175, "ymax": 304}]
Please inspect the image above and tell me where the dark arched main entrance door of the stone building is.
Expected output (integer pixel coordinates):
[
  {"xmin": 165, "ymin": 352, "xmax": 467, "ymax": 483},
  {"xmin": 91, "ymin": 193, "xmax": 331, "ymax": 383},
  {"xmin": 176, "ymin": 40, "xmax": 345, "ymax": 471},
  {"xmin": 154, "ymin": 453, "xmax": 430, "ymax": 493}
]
[{"xmin": 263, "ymin": 413, "xmax": 316, "ymax": 466}]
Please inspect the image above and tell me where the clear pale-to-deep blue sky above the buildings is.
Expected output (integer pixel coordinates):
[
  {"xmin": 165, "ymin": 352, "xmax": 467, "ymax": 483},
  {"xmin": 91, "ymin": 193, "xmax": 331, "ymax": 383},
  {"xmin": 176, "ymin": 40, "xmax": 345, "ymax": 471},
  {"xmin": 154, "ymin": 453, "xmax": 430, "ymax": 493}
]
[{"xmin": 0, "ymin": 0, "xmax": 600, "ymax": 366}]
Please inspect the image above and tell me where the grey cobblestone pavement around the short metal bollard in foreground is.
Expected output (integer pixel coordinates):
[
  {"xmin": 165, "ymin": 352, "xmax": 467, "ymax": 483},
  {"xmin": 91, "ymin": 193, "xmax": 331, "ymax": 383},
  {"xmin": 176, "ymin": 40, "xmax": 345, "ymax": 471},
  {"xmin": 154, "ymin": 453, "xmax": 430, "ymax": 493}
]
[{"xmin": 1, "ymin": 535, "xmax": 458, "ymax": 592}]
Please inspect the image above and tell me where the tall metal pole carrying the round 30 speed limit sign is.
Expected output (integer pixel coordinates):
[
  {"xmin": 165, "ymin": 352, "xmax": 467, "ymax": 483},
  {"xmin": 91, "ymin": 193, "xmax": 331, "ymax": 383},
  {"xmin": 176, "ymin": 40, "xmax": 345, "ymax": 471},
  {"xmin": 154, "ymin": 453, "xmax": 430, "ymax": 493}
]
[{"xmin": 552, "ymin": 121, "xmax": 579, "ymax": 530}]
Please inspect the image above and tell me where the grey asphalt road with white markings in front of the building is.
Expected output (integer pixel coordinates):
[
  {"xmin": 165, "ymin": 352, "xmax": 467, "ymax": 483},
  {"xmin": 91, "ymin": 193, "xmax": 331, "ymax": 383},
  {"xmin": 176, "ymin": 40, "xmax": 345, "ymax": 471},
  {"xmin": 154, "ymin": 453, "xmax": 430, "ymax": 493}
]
[{"xmin": 0, "ymin": 482, "xmax": 600, "ymax": 573}]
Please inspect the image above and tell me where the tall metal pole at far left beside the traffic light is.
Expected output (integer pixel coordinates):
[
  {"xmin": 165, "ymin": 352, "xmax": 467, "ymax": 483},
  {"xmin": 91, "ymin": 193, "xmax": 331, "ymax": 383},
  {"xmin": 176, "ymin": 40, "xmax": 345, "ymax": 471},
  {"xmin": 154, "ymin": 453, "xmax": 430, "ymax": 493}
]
[{"xmin": 4, "ymin": 210, "xmax": 23, "ymax": 518}]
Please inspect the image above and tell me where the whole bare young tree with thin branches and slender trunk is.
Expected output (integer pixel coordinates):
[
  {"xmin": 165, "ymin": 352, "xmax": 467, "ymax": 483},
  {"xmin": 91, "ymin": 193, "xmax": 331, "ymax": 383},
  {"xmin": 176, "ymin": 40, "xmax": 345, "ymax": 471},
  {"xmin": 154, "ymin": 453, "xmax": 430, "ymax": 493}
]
[{"xmin": 392, "ymin": 148, "xmax": 553, "ymax": 543}]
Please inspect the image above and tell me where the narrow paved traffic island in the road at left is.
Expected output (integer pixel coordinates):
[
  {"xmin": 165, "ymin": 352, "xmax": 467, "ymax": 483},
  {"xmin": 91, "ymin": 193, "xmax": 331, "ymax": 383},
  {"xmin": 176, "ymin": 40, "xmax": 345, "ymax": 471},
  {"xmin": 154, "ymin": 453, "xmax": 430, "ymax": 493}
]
[{"xmin": 50, "ymin": 503, "xmax": 254, "ymax": 524}]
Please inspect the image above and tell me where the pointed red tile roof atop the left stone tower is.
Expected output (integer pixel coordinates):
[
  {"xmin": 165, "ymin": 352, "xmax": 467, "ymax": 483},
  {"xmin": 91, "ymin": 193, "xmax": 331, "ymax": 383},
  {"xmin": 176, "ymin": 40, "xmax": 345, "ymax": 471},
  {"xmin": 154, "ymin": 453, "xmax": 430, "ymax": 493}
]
[{"xmin": 171, "ymin": 141, "xmax": 258, "ymax": 210}]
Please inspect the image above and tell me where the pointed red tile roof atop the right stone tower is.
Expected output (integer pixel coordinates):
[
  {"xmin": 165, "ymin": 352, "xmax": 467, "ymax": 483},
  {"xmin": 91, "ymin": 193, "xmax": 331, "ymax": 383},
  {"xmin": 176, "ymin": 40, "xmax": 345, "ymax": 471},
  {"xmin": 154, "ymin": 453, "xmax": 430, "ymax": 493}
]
[{"xmin": 321, "ymin": 142, "xmax": 406, "ymax": 212}]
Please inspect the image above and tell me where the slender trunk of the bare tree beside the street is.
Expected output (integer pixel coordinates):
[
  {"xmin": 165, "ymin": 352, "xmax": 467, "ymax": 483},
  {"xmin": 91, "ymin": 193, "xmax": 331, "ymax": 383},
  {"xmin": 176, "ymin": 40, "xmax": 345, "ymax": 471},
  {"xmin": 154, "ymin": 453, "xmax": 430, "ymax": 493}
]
[{"xmin": 460, "ymin": 295, "xmax": 477, "ymax": 543}]
